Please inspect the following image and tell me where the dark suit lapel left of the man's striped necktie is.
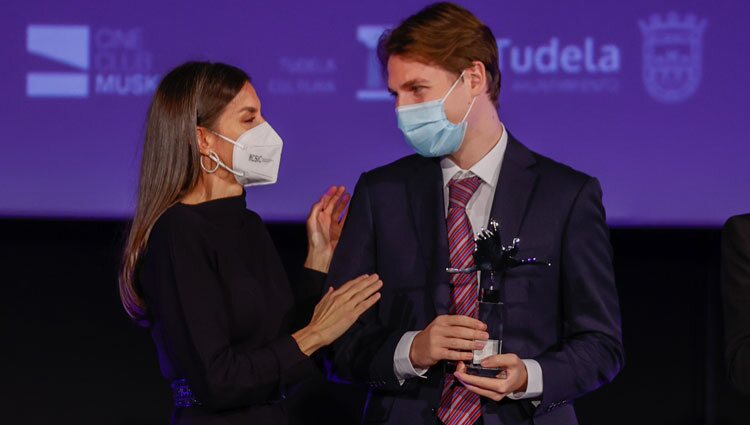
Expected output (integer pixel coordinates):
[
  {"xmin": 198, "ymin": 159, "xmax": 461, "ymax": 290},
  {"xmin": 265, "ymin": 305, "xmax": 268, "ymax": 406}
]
[{"xmin": 407, "ymin": 158, "xmax": 450, "ymax": 315}]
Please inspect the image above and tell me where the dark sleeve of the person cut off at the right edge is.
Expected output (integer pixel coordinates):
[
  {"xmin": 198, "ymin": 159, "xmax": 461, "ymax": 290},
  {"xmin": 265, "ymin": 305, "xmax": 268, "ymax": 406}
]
[{"xmin": 721, "ymin": 216, "xmax": 750, "ymax": 394}]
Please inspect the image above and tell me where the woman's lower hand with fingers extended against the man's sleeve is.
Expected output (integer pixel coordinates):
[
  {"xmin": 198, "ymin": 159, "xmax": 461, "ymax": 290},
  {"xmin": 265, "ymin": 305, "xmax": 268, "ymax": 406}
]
[{"xmin": 292, "ymin": 274, "xmax": 383, "ymax": 356}]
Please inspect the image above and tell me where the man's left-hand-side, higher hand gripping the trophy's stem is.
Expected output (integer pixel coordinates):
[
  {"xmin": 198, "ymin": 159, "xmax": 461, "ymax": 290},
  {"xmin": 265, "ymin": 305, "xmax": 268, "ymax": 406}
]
[{"xmin": 409, "ymin": 315, "xmax": 489, "ymax": 369}]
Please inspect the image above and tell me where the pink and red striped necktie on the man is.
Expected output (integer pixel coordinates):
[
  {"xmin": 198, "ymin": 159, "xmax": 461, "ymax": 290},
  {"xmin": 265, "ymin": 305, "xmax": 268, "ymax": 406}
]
[{"xmin": 438, "ymin": 177, "xmax": 482, "ymax": 425}]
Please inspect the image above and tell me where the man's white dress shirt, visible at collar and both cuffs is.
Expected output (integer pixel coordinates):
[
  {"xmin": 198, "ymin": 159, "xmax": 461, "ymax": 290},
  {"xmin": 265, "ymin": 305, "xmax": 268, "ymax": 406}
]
[{"xmin": 393, "ymin": 123, "xmax": 542, "ymax": 400}]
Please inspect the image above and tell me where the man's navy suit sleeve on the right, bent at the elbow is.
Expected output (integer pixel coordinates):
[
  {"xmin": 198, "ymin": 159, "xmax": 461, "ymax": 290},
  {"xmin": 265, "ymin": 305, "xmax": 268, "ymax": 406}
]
[{"xmin": 535, "ymin": 179, "xmax": 625, "ymax": 414}]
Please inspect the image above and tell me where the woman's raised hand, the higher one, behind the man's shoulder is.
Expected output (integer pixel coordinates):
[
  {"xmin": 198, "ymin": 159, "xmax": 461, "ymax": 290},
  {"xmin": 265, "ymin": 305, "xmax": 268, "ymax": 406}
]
[{"xmin": 305, "ymin": 186, "xmax": 351, "ymax": 273}]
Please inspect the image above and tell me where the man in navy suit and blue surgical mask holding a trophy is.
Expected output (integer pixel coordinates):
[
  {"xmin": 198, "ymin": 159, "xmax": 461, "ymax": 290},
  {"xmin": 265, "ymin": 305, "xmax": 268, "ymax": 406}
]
[{"xmin": 328, "ymin": 3, "xmax": 624, "ymax": 425}]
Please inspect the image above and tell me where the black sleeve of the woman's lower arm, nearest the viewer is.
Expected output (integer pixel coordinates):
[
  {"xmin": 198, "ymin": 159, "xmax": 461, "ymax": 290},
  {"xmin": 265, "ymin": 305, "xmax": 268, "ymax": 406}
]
[{"xmin": 140, "ymin": 212, "xmax": 309, "ymax": 410}]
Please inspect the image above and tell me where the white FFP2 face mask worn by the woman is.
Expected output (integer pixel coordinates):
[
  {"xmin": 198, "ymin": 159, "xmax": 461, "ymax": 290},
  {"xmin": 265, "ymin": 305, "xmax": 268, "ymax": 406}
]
[{"xmin": 201, "ymin": 121, "xmax": 284, "ymax": 186}]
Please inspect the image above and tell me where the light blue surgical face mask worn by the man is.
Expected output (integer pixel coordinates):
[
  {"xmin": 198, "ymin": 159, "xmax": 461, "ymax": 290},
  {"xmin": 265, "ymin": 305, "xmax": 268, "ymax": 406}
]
[{"xmin": 396, "ymin": 72, "xmax": 477, "ymax": 157}]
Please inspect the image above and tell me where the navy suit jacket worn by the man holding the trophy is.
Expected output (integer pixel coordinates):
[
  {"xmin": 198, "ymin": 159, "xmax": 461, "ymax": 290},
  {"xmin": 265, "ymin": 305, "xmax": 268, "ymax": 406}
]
[{"xmin": 328, "ymin": 135, "xmax": 624, "ymax": 425}]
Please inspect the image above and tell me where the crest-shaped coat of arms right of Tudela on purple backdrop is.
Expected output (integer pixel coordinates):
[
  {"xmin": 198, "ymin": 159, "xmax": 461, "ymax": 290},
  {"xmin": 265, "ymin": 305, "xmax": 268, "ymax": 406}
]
[{"xmin": 639, "ymin": 12, "xmax": 707, "ymax": 103}]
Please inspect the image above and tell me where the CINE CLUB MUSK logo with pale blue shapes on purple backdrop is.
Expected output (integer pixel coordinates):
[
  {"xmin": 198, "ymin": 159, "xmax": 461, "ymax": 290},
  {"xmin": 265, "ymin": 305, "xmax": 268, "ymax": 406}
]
[{"xmin": 26, "ymin": 25, "xmax": 159, "ymax": 98}]
